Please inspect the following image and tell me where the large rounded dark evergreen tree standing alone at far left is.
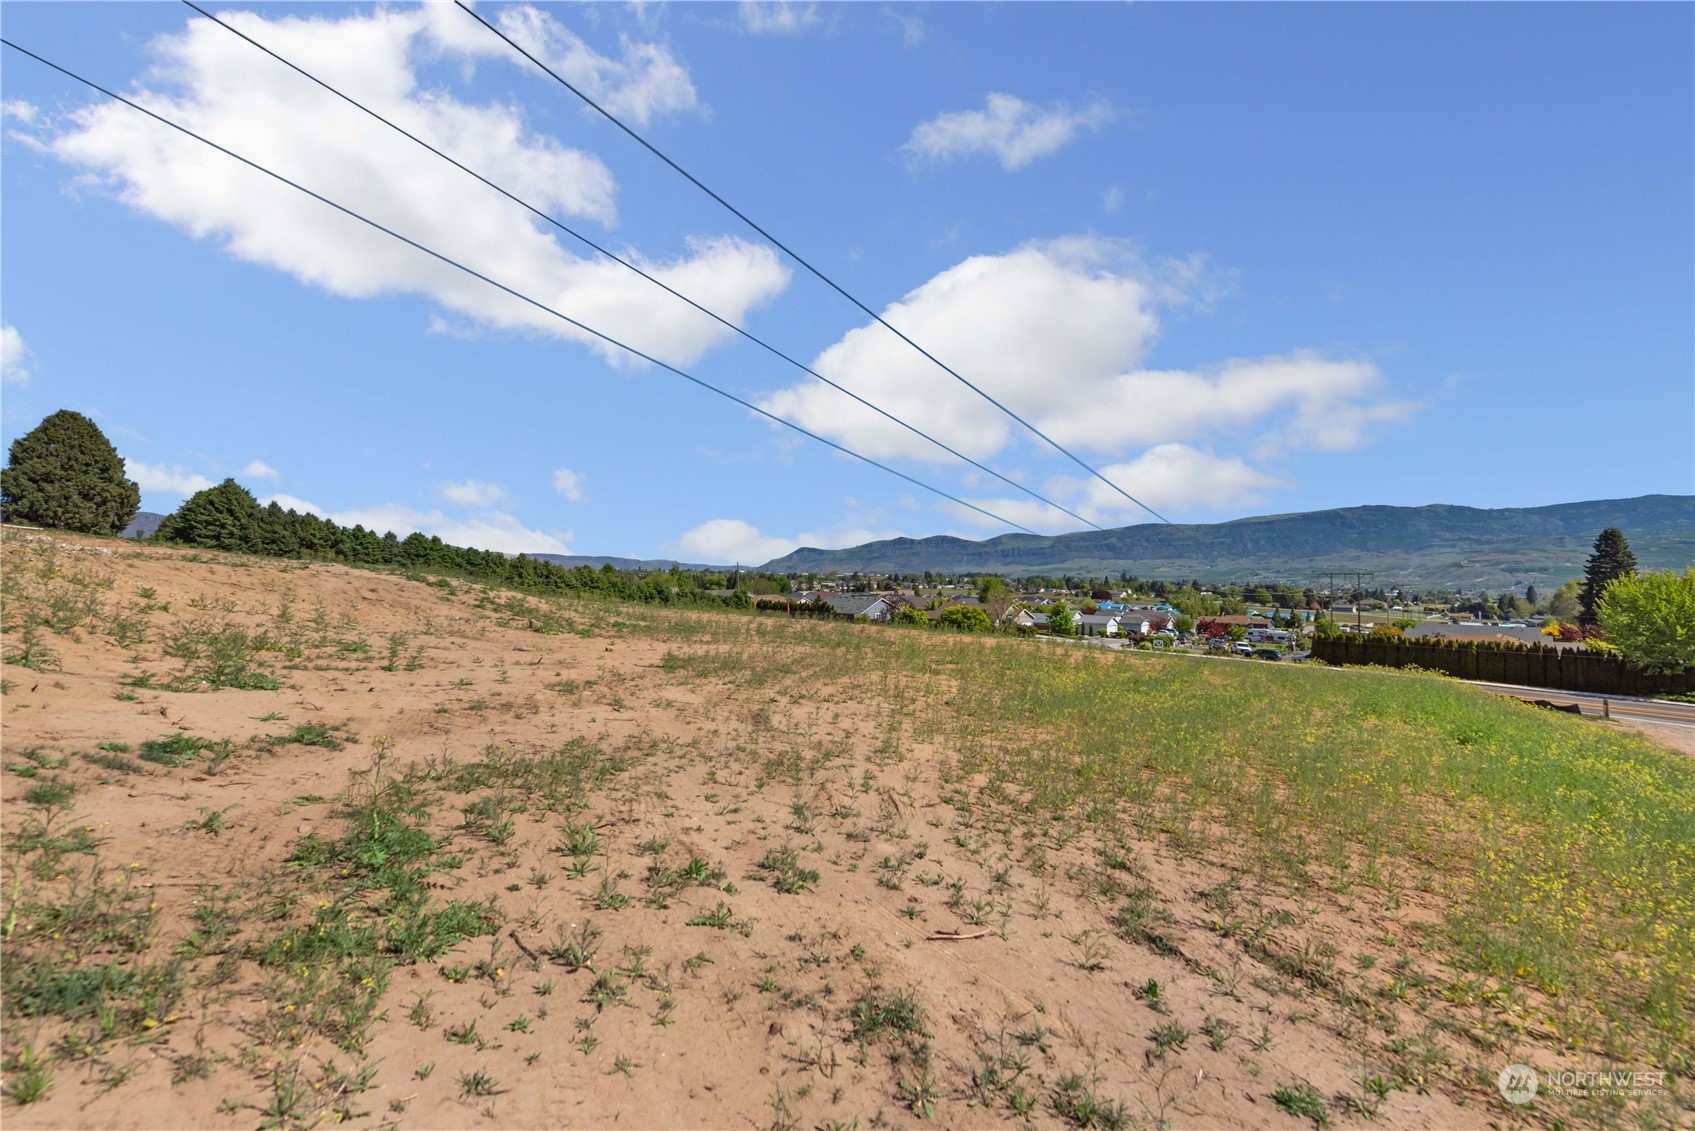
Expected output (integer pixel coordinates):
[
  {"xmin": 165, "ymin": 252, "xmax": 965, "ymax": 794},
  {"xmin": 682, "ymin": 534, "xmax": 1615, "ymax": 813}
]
[{"xmin": 0, "ymin": 409, "xmax": 141, "ymax": 534}]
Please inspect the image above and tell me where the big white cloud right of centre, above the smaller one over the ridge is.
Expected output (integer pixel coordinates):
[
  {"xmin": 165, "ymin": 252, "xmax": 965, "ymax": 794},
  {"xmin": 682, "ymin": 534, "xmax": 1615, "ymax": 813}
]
[{"xmin": 763, "ymin": 237, "xmax": 1412, "ymax": 468}]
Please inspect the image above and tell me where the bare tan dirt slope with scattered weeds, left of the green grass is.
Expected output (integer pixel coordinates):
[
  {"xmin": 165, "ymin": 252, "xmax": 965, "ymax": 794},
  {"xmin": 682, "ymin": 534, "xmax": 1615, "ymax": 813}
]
[{"xmin": 3, "ymin": 529, "xmax": 1667, "ymax": 1128}]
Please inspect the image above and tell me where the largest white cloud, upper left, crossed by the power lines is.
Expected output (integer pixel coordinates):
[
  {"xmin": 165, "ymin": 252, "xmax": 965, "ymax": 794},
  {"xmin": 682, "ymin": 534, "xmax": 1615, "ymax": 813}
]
[{"xmin": 41, "ymin": 5, "xmax": 788, "ymax": 365}]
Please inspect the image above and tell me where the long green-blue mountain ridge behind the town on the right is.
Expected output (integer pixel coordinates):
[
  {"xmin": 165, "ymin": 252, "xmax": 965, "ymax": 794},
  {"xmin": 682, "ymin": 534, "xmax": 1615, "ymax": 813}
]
[{"xmin": 761, "ymin": 495, "xmax": 1695, "ymax": 587}]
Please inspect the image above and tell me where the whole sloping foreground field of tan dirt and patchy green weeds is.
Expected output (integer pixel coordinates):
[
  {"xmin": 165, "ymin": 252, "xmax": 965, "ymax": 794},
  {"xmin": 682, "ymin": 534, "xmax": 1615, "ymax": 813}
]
[{"xmin": 0, "ymin": 531, "xmax": 1695, "ymax": 1128}]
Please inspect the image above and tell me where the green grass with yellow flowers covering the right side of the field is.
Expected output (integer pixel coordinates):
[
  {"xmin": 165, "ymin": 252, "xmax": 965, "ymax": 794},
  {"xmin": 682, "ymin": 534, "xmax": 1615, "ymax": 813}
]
[{"xmin": 644, "ymin": 609, "xmax": 1695, "ymax": 1070}]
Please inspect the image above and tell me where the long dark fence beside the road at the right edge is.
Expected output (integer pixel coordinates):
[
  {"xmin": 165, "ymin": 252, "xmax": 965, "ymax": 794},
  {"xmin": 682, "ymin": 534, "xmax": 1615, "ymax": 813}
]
[{"xmin": 1312, "ymin": 636, "xmax": 1695, "ymax": 695}]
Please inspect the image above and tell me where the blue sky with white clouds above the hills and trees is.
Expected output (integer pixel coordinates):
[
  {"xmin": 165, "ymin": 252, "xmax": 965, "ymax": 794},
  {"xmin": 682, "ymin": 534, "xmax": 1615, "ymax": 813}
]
[{"xmin": 0, "ymin": 3, "xmax": 1695, "ymax": 563}]
